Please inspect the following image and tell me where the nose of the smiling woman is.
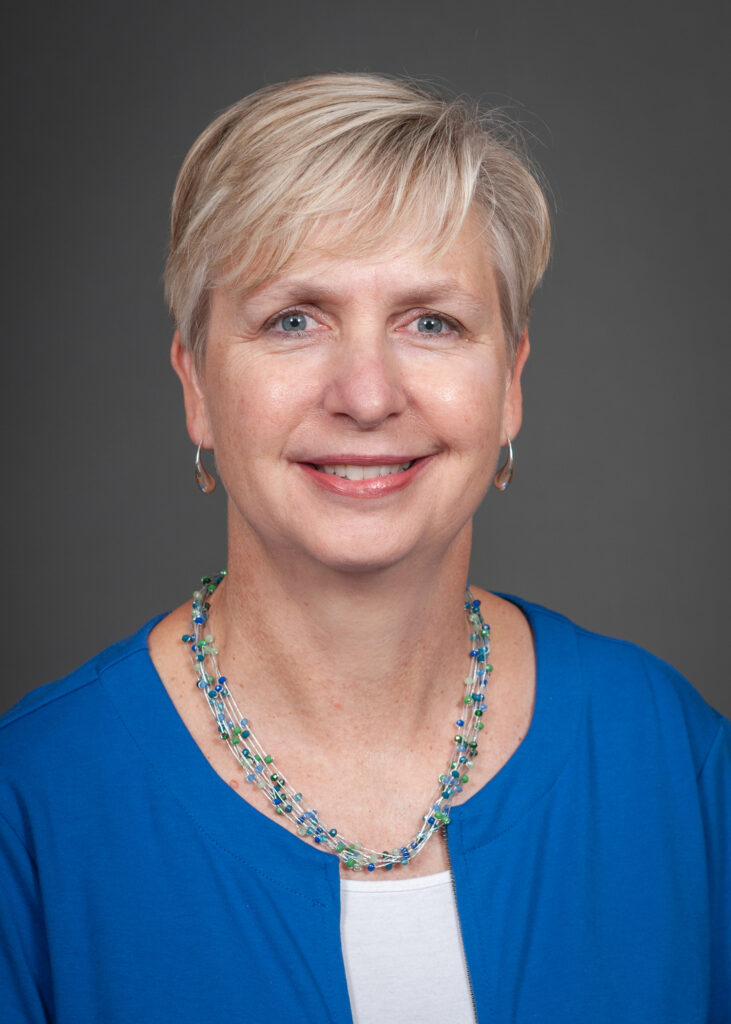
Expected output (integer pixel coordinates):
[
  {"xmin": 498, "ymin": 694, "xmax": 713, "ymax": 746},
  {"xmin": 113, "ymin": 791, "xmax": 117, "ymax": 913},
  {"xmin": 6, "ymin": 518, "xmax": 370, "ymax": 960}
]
[{"xmin": 324, "ymin": 324, "xmax": 406, "ymax": 430}]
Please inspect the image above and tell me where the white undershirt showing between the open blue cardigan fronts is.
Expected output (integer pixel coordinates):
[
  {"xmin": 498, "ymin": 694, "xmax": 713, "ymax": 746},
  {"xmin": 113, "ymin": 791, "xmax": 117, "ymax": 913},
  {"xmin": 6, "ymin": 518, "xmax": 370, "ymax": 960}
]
[{"xmin": 340, "ymin": 871, "xmax": 475, "ymax": 1024}]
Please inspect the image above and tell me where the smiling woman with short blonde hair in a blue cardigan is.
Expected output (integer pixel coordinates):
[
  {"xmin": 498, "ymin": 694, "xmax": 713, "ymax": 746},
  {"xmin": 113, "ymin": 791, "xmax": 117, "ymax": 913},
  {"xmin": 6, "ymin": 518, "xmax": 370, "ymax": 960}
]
[{"xmin": 0, "ymin": 75, "xmax": 731, "ymax": 1024}]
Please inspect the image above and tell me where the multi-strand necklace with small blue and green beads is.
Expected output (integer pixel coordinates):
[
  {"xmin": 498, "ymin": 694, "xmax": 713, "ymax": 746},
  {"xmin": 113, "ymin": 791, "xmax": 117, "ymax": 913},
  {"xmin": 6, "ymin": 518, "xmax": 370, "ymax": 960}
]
[{"xmin": 182, "ymin": 569, "xmax": 492, "ymax": 871}]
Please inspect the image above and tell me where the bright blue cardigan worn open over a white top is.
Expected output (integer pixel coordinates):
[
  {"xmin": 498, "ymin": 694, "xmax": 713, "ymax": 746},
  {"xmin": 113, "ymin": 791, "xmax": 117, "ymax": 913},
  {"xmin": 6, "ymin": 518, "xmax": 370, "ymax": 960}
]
[{"xmin": 0, "ymin": 600, "xmax": 731, "ymax": 1024}]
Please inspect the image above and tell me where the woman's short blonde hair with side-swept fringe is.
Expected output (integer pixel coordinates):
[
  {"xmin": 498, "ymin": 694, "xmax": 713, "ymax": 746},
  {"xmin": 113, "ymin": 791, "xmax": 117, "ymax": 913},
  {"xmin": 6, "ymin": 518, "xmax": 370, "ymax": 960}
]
[{"xmin": 165, "ymin": 74, "xmax": 550, "ymax": 365}]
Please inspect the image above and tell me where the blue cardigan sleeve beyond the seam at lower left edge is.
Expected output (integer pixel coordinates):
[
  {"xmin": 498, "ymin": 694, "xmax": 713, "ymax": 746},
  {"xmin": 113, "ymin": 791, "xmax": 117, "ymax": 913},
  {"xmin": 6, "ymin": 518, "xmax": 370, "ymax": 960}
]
[{"xmin": 0, "ymin": 818, "xmax": 51, "ymax": 1024}]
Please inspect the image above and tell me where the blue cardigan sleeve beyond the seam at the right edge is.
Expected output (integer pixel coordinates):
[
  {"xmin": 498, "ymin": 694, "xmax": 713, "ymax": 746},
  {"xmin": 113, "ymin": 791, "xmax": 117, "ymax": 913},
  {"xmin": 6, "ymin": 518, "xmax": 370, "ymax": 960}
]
[{"xmin": 698, "ymin": 719, "xmax": 731, "ymax": 1024}]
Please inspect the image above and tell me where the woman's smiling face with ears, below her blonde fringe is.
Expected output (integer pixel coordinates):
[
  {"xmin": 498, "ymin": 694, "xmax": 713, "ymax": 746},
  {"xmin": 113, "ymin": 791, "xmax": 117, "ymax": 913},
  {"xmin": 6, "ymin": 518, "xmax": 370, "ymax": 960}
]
[{"xmin": 173, "ymin": 210, "xmax": 528, "ymax": 570}]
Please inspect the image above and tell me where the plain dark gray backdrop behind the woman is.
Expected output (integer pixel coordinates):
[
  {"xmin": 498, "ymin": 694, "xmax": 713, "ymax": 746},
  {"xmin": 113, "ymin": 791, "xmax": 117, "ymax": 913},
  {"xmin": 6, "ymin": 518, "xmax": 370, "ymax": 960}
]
[{"xmin": 2, "ymin": 0, "xmax": 731, "ymax": 712}]
